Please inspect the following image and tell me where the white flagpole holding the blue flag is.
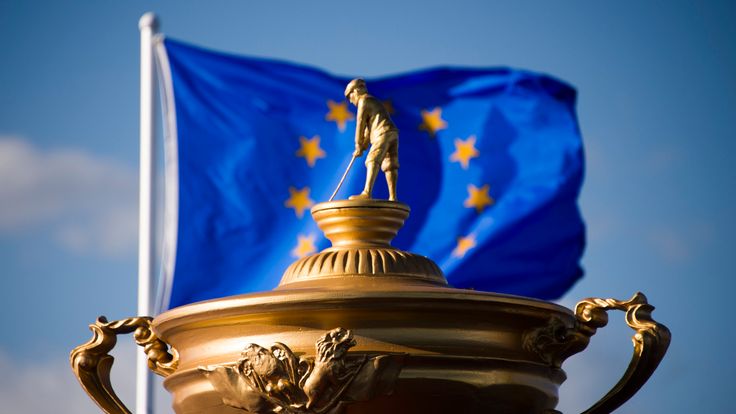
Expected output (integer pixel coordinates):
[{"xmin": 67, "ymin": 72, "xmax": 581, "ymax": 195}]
[{"xmin": 135, "ymin": 12, "xmax": 158, "ymax": 414}]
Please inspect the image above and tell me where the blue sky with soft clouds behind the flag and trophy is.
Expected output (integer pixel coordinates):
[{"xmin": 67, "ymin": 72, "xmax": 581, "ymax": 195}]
[{"xmin": 0, "ymin": 0, "xmax": 736, "ymax": 413}]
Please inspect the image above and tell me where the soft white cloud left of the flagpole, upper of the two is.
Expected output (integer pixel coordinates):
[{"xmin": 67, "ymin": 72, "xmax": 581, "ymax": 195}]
[{"xmin": 0, "ymin": 136, "xmax": 138, "ymax": 256}]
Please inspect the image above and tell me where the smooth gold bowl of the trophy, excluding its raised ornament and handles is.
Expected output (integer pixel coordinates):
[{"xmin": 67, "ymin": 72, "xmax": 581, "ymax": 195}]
[{"xmin": 155, "ymin": 283, "xmax": 574, "ymax": 413}]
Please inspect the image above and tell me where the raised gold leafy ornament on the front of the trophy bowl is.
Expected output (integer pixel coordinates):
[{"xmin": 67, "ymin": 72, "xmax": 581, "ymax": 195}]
[{"xmin": 199, "ymin": 328, "xmax": 403, "ymax": 414}]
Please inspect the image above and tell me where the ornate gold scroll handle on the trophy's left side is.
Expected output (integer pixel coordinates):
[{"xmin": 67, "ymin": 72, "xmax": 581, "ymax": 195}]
[{"xmin": 69, "ymin": 316, "xmax": 179, "ymax": 414}]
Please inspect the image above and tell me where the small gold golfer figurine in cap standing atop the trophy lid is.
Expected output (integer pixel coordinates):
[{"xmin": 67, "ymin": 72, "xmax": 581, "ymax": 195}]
[{"xmin": 345, "ymin": 79, "xmax": 399, "ymax": 201}]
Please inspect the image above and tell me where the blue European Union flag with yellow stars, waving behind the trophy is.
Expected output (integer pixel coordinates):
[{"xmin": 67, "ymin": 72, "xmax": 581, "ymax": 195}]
[{"xmin": 158, "ymin": 39, "xmax": 585, "ymax": 307}]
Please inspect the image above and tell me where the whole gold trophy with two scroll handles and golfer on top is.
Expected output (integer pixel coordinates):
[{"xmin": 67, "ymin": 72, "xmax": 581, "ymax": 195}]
[{"xmin": 70, "ymin": 80, "xmax": 670, "ymax": 414}]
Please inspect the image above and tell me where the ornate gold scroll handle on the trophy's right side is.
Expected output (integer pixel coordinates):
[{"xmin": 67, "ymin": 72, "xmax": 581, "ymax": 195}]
[{"xmin": 575, "ymin": 292, "xmax": 671, "ymax": 414}]
